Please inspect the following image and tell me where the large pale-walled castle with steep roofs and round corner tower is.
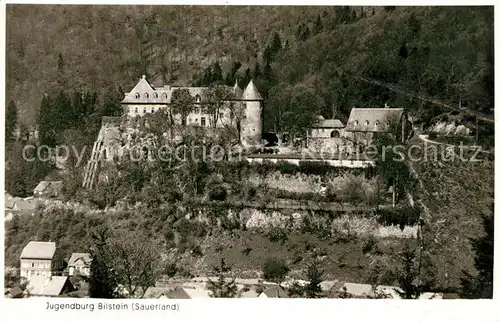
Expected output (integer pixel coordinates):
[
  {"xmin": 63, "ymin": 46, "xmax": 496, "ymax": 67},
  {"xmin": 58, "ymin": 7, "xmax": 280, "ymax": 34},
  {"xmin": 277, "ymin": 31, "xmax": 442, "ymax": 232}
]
[{"xmin": 121, "ymin": 75, "xmax": 263, "ymax": 145}]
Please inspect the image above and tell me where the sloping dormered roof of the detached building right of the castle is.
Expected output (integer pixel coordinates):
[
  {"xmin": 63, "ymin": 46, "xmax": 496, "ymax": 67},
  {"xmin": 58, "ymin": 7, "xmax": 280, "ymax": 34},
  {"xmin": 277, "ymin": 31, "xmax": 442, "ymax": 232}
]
[{"xmin": 345, "ymin": 108, "xmax": 404, "ymax": 132}]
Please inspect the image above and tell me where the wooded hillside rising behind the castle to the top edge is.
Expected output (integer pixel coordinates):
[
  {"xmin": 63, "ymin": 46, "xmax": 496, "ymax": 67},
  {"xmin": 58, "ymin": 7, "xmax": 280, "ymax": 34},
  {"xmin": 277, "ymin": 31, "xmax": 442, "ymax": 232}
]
[{"xmin": 6, "ymin": 5, "xmax": 494, "ymax": 132}]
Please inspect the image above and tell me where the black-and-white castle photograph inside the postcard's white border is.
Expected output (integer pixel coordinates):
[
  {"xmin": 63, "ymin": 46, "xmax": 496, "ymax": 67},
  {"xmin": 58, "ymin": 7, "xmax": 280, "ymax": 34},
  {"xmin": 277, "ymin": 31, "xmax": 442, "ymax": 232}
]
[{"xmin": 2, "ymin": 3, "xmax": 495, "ymax": 302}]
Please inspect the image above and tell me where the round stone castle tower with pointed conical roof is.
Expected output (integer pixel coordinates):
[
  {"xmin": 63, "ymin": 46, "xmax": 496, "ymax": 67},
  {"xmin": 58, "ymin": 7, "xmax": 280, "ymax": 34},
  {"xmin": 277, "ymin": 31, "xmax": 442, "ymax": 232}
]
[{"xmin": 241, "ymin": 80, "xmax": 264, "ymax": 146}]
